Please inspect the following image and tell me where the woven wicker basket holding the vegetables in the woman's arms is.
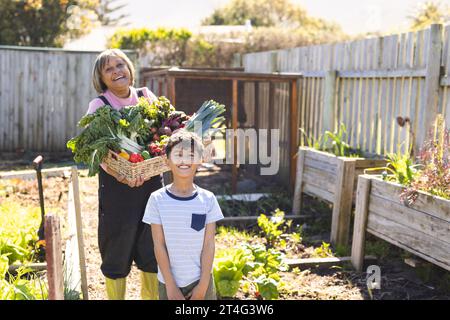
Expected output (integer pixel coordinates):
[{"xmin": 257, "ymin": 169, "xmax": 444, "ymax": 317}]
[{"xmin": 105, "ymin": 150, "xmax": 170, "ymax": 180}]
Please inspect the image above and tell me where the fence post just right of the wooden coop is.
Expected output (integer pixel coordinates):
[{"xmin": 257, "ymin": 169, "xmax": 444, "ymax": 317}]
[{"xmin": 322, "ymin": 70, "xmax": 337, "ymax": 132}]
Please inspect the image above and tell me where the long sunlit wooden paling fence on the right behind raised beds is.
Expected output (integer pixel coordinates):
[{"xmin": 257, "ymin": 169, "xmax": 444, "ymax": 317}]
[{"xmin": 243, "ymin": 25, "xmax": 450, "ymax": 184}]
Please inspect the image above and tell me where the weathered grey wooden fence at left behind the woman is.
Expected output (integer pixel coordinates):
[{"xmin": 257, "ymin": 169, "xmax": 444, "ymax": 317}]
[{"xmin": 0, "ymin": 46, "xmax": 136, "ymax": 152}]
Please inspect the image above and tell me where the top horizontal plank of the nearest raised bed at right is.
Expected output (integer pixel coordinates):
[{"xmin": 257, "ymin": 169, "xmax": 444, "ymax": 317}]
[{"xmin": 372, "ymin": 178, "xmax": 450, "ymax": 222}]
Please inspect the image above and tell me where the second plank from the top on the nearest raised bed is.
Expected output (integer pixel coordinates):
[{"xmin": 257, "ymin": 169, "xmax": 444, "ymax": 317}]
[{"xmin": 369, "ymin": 194, "xmax": 450, "ymax": 245}]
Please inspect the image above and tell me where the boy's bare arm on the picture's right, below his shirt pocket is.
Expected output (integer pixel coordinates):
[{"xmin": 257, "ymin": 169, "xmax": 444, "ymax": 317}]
[{"xmin": 190, "ymin": 222, "xmax": 216, "ymax": 300}]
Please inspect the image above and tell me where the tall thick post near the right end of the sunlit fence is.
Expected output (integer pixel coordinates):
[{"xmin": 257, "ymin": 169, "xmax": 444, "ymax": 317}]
[{"xmin": 415, "ymin": 24, "xmax": 443, "ymax": 150}]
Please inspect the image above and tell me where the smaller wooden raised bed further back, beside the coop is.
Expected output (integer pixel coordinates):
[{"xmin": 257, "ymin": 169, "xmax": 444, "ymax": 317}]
[{"xmin": 292, "ymin": 147, "xmax": 386, "ymax": 245}]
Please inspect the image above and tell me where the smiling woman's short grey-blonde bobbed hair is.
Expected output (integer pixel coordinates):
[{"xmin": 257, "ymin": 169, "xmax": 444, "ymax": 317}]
[{"xmin": 92, "ymin": 49, "xmax": 135, "ymax": 93}]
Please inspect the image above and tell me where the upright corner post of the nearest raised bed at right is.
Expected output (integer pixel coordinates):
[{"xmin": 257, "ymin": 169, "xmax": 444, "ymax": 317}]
[{"xmin": 352, "ymin": 176, "xmax": 371, "ymax": 271}]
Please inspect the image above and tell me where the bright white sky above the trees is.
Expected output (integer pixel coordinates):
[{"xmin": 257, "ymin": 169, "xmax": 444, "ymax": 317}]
[{"xmin": 113, "ymin": 0, "xmax": 440, "ymax": 34}]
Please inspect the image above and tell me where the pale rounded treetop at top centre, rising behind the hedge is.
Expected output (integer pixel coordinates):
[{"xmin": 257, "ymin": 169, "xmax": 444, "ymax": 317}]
[{"xmin": 202, "ymin": 0, "xmax": 340, "ymax": 32}]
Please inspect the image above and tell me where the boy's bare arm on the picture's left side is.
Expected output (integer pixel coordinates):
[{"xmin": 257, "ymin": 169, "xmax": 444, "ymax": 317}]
[{"xmin": 151, "ymin": 223, "xmax": 185, "ymax": 300}]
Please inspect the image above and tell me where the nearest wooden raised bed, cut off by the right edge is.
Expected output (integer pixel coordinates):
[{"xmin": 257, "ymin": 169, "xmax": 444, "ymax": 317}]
[{"xmin": 352, "ymin": 175, "xmax": 450, "ymax": 271}]
